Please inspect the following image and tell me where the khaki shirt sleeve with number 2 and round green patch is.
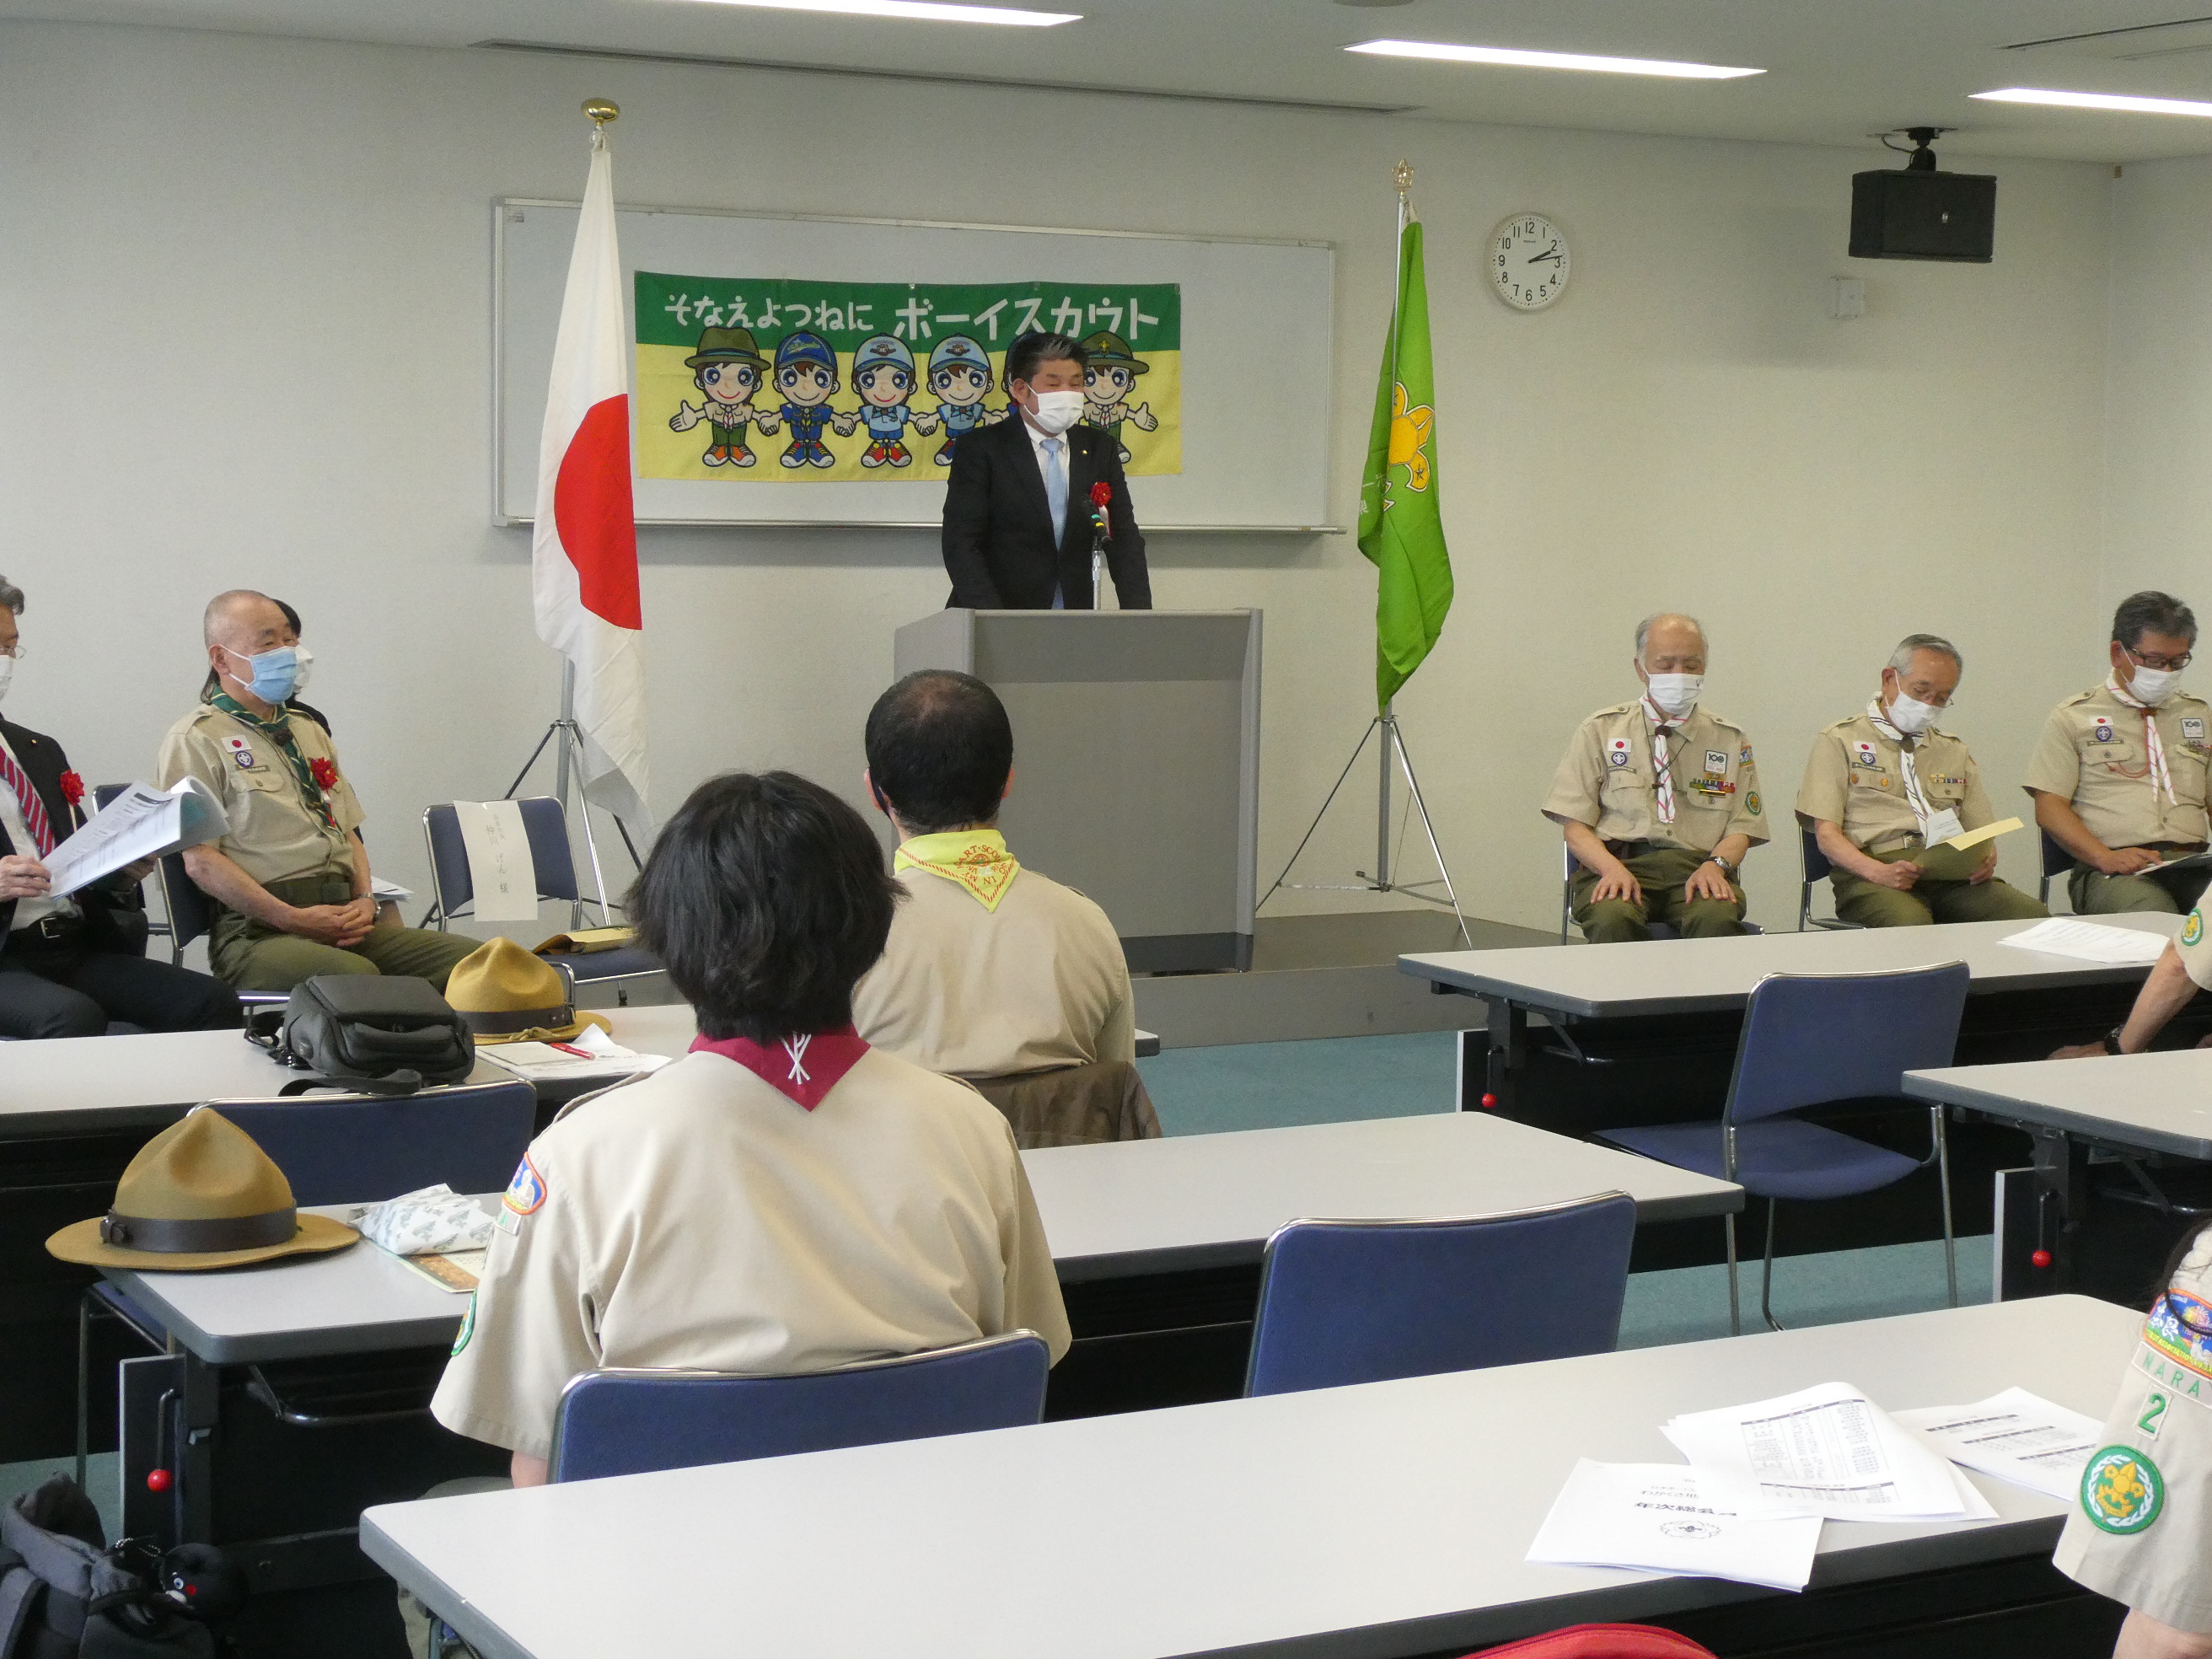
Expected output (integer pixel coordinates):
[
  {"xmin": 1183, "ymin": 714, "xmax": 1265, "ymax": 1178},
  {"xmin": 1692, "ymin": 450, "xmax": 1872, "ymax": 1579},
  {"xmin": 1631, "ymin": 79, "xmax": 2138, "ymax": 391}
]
[{"xmin": 2050, "ymin": 1232, "xmax": 2212, "ymax": 1635}]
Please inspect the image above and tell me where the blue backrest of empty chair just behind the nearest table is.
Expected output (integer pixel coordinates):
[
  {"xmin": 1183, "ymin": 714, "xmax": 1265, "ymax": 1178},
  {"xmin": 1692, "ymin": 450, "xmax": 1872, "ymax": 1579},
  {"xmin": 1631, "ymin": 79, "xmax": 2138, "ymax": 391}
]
[{"xmin": 1245, "ymin": 1192, "xmax": 1637, "ymax": 1396}]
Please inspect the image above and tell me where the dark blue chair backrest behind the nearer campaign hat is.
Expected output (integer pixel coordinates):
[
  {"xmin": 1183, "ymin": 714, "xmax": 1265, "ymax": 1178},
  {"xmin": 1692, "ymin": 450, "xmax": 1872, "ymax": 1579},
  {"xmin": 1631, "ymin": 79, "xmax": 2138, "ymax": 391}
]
[{"xmin": 208, "ymin": 1082, "xmax": 538, "ymax": 1203}]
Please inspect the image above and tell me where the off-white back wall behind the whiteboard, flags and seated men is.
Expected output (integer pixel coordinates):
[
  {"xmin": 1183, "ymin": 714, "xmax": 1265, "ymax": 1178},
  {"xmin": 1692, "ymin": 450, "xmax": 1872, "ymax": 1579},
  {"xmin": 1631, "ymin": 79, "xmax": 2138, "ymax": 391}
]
[{"xmin": 0, "ymin": 22, "xmax": 2106, "ymax": 942}]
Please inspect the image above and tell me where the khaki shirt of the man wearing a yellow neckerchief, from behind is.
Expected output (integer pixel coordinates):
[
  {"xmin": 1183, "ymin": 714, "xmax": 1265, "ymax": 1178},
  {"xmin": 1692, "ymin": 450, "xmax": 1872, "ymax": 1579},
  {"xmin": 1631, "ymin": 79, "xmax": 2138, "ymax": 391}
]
[{"xmin": 851, "ymin": 867, "xmax": 1137, "ymax": 1077}]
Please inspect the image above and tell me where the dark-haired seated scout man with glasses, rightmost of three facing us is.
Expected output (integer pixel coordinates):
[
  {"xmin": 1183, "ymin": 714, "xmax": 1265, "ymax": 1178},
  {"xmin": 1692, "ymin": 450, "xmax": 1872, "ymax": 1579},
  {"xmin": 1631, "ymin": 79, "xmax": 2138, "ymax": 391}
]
[{"xmin": 2021, "ymin": 591, "xmax": 2212, "ymax": 915}]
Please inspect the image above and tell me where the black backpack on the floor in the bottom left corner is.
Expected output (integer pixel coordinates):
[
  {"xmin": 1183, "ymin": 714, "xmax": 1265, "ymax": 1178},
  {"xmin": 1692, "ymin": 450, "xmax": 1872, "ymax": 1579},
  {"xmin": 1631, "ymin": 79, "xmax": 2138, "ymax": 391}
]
[{"xmin": 0, "ymin": 1475, "xmax": 245, "ymax": 1659}]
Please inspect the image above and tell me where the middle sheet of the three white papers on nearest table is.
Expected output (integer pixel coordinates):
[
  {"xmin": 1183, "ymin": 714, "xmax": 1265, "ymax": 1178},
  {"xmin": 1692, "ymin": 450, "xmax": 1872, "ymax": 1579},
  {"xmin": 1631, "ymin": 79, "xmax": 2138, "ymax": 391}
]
[{"xmin": 1662, "ymin": 1382, "xmax": 1997, "ymax": 1522}]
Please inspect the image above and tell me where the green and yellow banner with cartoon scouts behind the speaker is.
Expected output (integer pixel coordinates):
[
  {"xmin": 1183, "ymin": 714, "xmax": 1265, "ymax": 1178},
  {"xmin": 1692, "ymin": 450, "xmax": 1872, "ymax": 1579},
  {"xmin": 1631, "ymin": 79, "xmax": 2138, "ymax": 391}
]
[{"xmin": 637, "ymin": 270, "xmax": 1184, "ymax": 485}]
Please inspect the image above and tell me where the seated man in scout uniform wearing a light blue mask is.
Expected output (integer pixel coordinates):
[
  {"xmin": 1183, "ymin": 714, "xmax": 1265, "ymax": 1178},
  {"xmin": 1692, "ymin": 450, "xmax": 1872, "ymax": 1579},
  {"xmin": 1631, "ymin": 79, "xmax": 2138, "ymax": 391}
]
[{"xmin": 155, "ymin": 588, "xmax": 480, "ymax": 991}]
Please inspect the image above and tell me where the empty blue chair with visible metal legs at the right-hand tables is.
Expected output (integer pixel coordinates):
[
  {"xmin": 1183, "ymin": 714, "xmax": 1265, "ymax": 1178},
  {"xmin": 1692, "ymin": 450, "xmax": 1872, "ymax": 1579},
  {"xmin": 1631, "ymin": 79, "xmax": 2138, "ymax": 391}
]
[{"xmin": 1597, "ymin": 962, "xmax": 1971, "ymax": 1334}]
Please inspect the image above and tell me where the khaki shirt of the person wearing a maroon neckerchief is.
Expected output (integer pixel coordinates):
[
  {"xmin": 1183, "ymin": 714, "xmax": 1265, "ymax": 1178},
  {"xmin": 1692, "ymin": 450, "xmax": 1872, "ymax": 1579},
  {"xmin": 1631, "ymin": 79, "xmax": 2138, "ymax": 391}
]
[{"xmin": 432, "ymin": 1049, "xmax": 1068, "ymax": 1458}]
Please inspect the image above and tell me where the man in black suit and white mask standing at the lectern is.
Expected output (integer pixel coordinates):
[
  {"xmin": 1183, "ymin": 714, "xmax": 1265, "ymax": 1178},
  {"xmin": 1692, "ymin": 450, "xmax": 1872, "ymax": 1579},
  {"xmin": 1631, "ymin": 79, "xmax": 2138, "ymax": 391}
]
[{"xmin": 944, "ymin": 334, "xmax": 1152, "ymax": 610}]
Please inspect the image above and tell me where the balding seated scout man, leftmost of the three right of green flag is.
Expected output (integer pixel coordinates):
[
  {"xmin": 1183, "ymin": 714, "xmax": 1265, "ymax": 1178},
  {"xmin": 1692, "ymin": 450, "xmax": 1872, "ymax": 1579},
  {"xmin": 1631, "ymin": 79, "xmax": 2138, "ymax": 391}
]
[{"xmin": 1544, "ymin": 613, "xmax": 1768, "ymax": 944}]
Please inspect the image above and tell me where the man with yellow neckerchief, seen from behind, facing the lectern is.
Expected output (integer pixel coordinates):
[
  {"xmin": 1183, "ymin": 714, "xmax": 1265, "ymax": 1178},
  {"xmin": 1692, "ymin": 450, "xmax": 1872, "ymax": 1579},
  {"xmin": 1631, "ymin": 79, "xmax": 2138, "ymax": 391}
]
[{"xmin": 851, "ymin": 668, "xmax": 1137, "ymax": 1077}]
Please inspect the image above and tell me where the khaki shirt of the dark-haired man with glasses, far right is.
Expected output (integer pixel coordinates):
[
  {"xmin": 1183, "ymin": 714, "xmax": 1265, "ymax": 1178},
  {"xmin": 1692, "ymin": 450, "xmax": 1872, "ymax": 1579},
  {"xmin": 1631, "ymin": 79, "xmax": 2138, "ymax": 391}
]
[{"xmin": 2021, "ymin": 685, "xmax": 2212, "ymax": 847}]
